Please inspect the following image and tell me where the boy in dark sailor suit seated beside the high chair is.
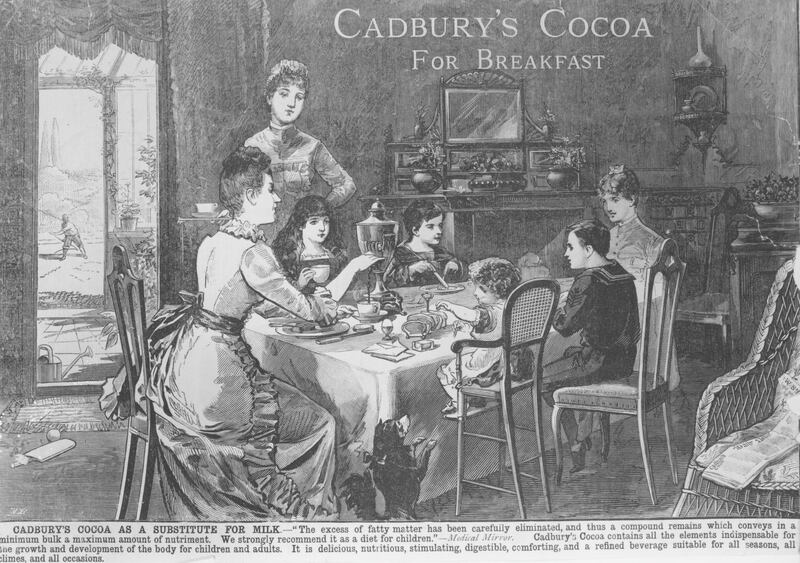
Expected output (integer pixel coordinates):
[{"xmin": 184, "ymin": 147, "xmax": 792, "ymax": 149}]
[{"xmin": 543, "ymin": 220, "xmax": 640, "ymax": 473}]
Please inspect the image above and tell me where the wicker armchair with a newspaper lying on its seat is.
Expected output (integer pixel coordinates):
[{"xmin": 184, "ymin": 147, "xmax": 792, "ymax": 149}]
[{"xmin": 673, "ymin": 260, "xmax": 800, "ymax": 518}]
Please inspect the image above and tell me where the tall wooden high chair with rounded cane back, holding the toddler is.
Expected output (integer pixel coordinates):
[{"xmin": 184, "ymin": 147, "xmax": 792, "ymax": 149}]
[{"xmin": 447, "ymin": 279, "xmax": 559, "ymax": 519}]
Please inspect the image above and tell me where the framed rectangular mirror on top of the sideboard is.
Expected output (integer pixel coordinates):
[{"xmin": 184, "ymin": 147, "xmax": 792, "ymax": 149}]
[{"xmin": 442, "ymin": 70, "xmax": 525, "ymax": 143}]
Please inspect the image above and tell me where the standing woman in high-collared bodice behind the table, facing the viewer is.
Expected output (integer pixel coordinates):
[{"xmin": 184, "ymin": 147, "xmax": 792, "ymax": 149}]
[{"xmin": 244, "ymin": 60, "xmax": 356, "ymax": 238}]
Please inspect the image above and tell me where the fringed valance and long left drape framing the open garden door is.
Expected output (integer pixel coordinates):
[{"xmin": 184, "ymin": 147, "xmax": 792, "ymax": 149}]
[{"xmin": 0, "ymin": 0, "xmax": 164, "ymax": 397}]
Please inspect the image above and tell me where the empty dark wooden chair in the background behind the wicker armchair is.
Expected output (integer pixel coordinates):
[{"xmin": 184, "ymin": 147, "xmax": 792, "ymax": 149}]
[{"xmin": 675, "ymin": 189, "xmax": 740, "ymax": 368}]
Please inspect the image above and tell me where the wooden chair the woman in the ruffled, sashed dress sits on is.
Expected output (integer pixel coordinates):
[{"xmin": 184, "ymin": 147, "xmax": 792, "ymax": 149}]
[{"xmin": 106, "ymin": 246, "xmax": 157, "ymax": 520}]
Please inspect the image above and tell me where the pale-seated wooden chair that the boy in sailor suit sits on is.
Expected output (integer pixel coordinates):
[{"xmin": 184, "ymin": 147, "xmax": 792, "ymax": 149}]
[{"xmin": 552, "ymin": 239, "xmax": 686, "ymax": 504}]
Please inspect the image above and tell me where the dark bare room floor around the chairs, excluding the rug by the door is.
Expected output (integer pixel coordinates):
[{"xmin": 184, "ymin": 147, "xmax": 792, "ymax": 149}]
[{"xmin": 0, "ymin": 359, "xmax": 721, "ymax": 521}]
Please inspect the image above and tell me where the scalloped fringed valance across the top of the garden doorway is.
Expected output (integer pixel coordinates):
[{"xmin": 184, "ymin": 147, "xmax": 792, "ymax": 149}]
[{"xmin": 0, "ymin": 0, "xmax": 163, "ymax": 60}]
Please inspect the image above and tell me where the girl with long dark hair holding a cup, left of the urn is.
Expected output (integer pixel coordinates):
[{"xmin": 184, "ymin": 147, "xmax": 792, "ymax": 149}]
[{"xmin": 272, "ymin": 195, "xmax": 352, "ymax": 293}]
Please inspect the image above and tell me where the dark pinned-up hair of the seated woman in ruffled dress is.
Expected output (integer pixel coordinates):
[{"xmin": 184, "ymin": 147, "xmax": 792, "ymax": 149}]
[{"xmin": 219, "ymin": 146, "xmax": 272, "ymax": 217}]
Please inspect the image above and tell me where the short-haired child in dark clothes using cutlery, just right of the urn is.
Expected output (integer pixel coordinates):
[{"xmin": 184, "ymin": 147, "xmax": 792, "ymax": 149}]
[{"xmin": 384, "ymin": 199, "xmax": 466, "ymax": 287}]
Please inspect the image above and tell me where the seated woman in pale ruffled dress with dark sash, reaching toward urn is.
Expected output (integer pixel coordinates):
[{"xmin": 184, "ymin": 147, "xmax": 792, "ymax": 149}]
[{"xmin": 148, "ymin": 147, "xmax": 378, "ymax": 521}]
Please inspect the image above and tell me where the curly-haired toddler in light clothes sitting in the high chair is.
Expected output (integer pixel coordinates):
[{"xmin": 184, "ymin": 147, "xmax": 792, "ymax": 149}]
[{"xmin": 436, "ymin": 258, "xmax": 521, "ymax": 414}]
